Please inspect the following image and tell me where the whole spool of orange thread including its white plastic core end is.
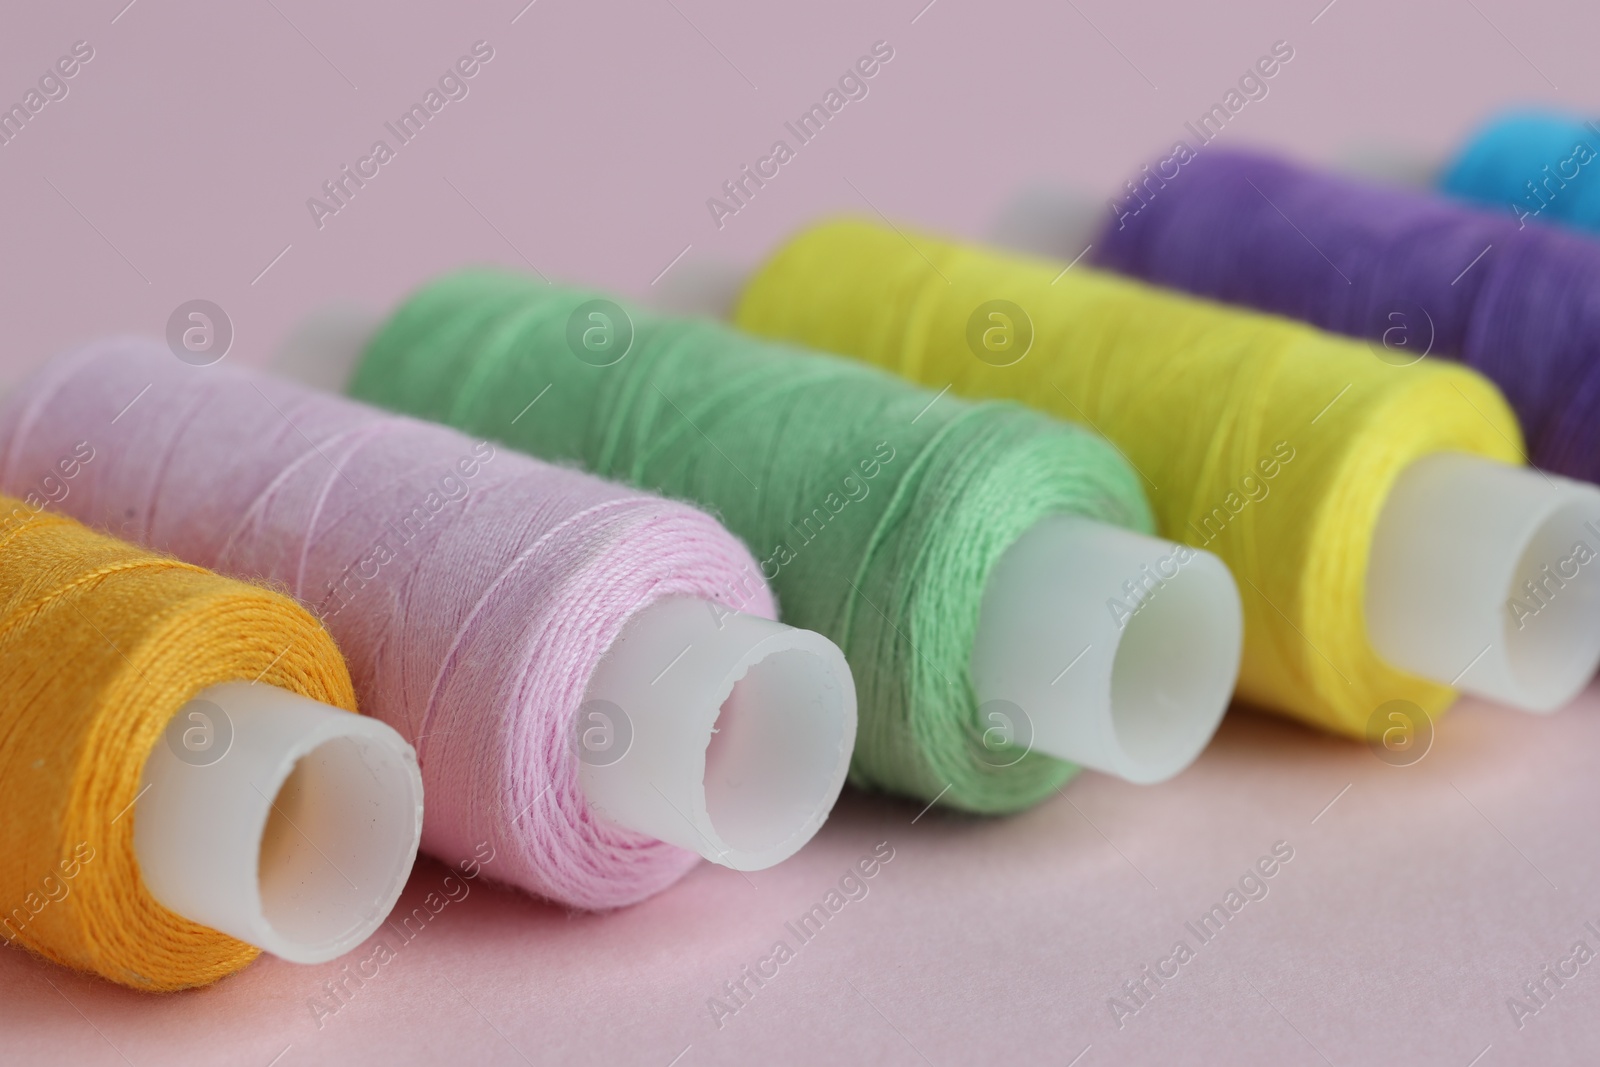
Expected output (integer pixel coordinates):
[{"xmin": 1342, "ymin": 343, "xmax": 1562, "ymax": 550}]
[{"xmin": 0, "ymin": 495, "xmax": 421, "ymax": 990}]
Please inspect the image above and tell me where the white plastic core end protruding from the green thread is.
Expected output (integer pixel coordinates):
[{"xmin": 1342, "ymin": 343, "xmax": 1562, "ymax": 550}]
[{"xmin": 973, "ymin": 515, "xmax": 1243, "ymax": 784}]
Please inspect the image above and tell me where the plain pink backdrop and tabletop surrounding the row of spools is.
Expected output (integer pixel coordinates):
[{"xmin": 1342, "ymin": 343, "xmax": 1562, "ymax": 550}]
[{"xmin": 0, "ymin": 0, "xmax": 1600, "ymax": 1067}]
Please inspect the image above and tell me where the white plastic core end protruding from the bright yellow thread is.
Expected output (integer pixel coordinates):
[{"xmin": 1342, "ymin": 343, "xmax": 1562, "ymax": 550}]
[{"xmin": 1366, "ymin": 453, "xmax": 1600, "ymax": 712}]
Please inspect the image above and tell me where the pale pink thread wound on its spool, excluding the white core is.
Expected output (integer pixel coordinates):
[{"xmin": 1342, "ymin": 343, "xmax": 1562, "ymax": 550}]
[{"xmin": 0, "ymin": 347, "xmax": 773, "ymax": 909}]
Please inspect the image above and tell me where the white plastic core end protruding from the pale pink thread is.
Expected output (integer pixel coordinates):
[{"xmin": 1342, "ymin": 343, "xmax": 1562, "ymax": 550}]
[{"xmin": 571, "ymin": 597, "xmax": 856, "ymax": 870}]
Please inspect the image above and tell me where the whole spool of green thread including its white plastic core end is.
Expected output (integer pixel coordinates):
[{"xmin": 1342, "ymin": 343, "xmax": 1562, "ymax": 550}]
[{"xmin": 321, "ymin": 270, "xmax": 1240, "ymax": 813}]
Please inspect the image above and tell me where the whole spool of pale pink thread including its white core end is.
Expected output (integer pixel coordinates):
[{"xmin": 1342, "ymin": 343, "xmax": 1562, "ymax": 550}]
[{"xmin": 0, "ymin": 339, "xmax": 854, "ymax": 909}]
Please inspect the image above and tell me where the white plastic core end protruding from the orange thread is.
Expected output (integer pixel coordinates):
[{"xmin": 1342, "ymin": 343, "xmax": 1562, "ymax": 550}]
[{"xmin": 133, "ymin": 681, "xmax": 422, "ymax": 963}]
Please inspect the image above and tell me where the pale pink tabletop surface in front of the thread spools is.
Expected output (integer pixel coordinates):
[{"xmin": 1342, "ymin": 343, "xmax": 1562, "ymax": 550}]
[{"xmin": 0, "ymin": 689, "xmax": 1600, "ymax": 1067}]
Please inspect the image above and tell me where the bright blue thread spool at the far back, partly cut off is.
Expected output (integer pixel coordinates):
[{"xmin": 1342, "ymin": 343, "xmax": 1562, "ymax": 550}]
[{"xmin": 1438, "ymin": 109, "xmax": 1600, "ymax": 235}]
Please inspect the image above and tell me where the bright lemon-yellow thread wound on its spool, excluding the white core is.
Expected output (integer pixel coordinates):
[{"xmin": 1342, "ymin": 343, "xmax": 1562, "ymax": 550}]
[{"xmin": 736, "ymin": 221, "xmax": 1522, "ymax": 736}]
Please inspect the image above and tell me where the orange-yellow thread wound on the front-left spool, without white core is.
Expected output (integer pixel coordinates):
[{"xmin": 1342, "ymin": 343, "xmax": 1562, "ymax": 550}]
[{"xmin": 0, "ymin": 496, "xmax": 355, "ymax": 990}]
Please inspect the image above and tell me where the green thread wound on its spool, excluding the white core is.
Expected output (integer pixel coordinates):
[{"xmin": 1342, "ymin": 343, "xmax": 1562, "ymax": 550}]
[{"xmin": 350, "ymin": 270, "xmax": 1150, "ymax": 813}]
